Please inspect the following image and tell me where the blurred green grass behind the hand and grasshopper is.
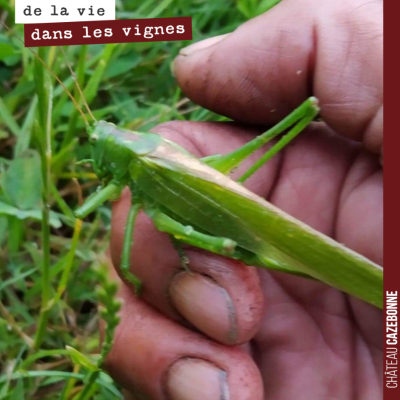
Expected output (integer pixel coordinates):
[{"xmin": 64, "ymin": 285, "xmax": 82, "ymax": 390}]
[{"xmin": 0, "ymin": 0, "xmax": 277, "ymax": 400}]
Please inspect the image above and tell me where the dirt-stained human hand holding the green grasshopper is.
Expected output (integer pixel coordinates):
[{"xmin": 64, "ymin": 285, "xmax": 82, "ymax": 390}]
[{"xmin": 107, "ymin": 0, "xmax": 383, "ymax": 400}]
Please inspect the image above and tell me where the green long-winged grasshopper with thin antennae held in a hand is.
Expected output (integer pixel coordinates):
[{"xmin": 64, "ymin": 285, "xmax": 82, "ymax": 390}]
[{"xmin": 7, "ymin": 27, "xmax": 383, "ymax": 308}]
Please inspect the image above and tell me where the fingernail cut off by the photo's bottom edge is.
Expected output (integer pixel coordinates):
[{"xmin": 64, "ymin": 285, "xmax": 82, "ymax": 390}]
[{"xmin": 166, "ymin": 358, "xmax": 229, "ymax": 400}]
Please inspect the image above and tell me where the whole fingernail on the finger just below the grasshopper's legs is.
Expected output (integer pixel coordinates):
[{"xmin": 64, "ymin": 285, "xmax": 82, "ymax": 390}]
[{"xmin": 169, "ymin": 272, "xmax": 238, "ymax": 344}]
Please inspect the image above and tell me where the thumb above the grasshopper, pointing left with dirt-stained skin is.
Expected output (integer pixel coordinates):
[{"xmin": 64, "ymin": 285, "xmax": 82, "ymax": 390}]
[{"xmin": 174, "ymin": 0, "xmax": 383, "ymax": 152}]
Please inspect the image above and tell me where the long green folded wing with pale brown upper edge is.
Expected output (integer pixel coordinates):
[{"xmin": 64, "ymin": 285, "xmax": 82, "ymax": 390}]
[{"xmin": 132, "ymin": 140, "xmax": 383, "ymax": 307}]
